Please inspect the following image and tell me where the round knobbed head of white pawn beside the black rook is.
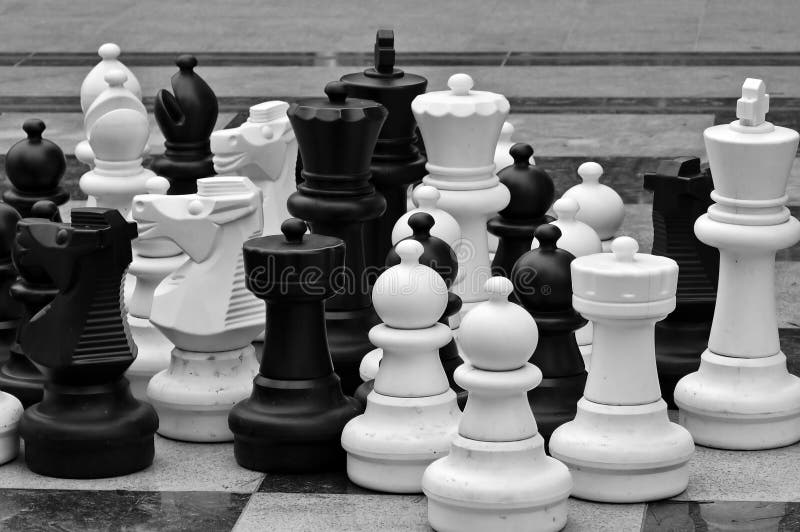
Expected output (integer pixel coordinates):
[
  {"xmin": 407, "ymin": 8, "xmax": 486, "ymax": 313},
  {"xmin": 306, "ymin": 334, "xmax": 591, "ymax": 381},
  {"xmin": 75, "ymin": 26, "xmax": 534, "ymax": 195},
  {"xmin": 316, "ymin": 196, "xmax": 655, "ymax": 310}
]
[{"xmin": 372, "ymin": 239, "xmax": 447, "ymax": 329}]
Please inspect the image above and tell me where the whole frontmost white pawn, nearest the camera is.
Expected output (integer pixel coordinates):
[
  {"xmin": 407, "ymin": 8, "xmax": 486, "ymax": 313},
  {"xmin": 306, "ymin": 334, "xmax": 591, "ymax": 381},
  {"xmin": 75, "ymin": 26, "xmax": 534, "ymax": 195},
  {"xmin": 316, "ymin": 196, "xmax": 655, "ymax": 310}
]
[{"xmin": 422, "ymin": 277, "xmax": 572, "ymax": 532}]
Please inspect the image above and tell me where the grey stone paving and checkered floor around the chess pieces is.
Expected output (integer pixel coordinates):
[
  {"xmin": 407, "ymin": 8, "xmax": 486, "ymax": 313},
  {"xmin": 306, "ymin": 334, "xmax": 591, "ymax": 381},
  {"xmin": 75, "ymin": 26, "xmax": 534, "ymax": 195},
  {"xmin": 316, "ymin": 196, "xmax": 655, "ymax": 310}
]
[{"xmin": 0, "ymin": 0, "xmax": 800, "ymax": 531}]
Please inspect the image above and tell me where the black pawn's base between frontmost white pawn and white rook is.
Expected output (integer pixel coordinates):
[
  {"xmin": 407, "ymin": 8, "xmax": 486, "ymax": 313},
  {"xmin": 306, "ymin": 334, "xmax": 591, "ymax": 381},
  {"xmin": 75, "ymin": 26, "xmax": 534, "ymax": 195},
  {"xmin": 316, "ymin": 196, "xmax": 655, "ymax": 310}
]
[{"xmin": 528, "ymin": 371, "xmax": 586, "ymax": 443}]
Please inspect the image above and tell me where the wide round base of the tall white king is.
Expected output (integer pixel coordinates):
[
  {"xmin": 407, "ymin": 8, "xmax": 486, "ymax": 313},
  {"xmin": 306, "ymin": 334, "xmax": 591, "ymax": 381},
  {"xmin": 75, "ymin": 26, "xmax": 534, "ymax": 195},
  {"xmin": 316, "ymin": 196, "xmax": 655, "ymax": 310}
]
[{"xmin": 675, "ymin": 350, "xmax": 800, "ymax": 450}]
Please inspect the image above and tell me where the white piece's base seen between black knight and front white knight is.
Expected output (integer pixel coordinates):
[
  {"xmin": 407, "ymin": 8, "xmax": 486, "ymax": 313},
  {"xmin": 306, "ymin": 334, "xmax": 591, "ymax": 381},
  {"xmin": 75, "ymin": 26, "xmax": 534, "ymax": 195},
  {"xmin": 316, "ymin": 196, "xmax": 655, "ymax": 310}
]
[{"xmin": 125, "ymin": 314, "xmax": 175, "ymax": 401}]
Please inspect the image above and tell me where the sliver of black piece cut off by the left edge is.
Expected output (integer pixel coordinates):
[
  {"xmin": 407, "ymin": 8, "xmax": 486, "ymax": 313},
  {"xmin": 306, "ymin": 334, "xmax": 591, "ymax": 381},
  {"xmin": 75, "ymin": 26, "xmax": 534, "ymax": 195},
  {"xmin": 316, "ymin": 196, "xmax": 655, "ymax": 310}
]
[{"xmin": 0, "ymin": 203, "xmax": 22, "ymax": 365}]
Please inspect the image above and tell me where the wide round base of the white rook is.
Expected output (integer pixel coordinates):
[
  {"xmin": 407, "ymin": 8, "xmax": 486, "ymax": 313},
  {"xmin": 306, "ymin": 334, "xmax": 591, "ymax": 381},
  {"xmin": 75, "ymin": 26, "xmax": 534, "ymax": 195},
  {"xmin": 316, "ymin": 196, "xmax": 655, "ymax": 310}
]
[{"xmin": 549, "ymin": 397, "xmax": 694, "ymax": 503}]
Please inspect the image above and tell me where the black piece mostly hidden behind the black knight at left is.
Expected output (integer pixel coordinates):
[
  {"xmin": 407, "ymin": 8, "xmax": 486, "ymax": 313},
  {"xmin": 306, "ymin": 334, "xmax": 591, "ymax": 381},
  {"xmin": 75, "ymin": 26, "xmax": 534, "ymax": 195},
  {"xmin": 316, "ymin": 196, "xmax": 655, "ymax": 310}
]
[{"xmin": 0, "ymin": 200, "xmax": 61, "ymax": 407}]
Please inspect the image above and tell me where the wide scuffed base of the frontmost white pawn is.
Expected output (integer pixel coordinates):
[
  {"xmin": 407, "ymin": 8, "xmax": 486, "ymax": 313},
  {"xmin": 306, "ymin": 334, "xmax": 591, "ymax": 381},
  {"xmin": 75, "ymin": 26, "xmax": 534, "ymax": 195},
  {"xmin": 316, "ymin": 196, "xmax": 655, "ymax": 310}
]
[{"xmin": 422, "ymin": 434, "xmax": 572, "ymax": 532}]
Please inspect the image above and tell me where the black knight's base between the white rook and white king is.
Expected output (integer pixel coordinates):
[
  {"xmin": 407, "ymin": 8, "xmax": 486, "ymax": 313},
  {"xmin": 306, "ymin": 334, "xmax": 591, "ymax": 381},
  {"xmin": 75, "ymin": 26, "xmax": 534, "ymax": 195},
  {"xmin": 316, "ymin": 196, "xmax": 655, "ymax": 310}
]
[{"xmin": 655, "ymin": 319, "xmax": 711, "ymax": 409}]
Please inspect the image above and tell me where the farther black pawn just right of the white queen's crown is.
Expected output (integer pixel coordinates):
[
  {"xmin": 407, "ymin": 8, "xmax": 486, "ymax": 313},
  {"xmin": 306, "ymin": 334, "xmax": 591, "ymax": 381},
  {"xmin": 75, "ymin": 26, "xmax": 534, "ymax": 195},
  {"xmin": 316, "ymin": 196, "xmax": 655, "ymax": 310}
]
[{"xmin": 486, "ymin": 143, "xmax": 555, "ymax": 277}]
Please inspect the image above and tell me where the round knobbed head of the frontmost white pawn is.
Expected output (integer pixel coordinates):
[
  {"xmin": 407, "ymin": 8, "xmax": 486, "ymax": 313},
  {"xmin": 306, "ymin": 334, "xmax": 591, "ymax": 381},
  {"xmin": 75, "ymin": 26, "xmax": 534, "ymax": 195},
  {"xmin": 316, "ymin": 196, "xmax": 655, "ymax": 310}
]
[{"xmin": 459, "ymin": 277, "xmax": 539, "ymax": 371}]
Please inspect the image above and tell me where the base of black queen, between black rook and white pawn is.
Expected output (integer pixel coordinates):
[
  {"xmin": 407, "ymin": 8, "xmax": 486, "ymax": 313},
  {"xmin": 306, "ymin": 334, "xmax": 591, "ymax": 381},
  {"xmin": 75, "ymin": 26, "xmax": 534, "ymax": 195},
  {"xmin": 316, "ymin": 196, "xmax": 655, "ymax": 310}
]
[{"xmin": 325, "ymin": 307, "xmax": 380, "ymax": 395}]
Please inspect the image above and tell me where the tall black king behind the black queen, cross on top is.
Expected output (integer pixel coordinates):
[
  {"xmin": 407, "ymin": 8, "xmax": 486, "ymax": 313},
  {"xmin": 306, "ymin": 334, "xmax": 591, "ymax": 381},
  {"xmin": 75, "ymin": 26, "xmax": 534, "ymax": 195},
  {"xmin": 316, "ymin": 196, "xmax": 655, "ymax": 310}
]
[{"xmin": 341, "ymin": 29, "xmax": 428, "ymax": 271}]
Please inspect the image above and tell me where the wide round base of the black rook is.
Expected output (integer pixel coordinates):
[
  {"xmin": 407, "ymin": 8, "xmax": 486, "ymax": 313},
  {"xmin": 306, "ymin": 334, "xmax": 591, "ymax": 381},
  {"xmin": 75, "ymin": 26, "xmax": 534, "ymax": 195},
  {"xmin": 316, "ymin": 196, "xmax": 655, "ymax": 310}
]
[{"xmin": 228, "ymin": 374, "xmax": 363, "ymax": 473}]
